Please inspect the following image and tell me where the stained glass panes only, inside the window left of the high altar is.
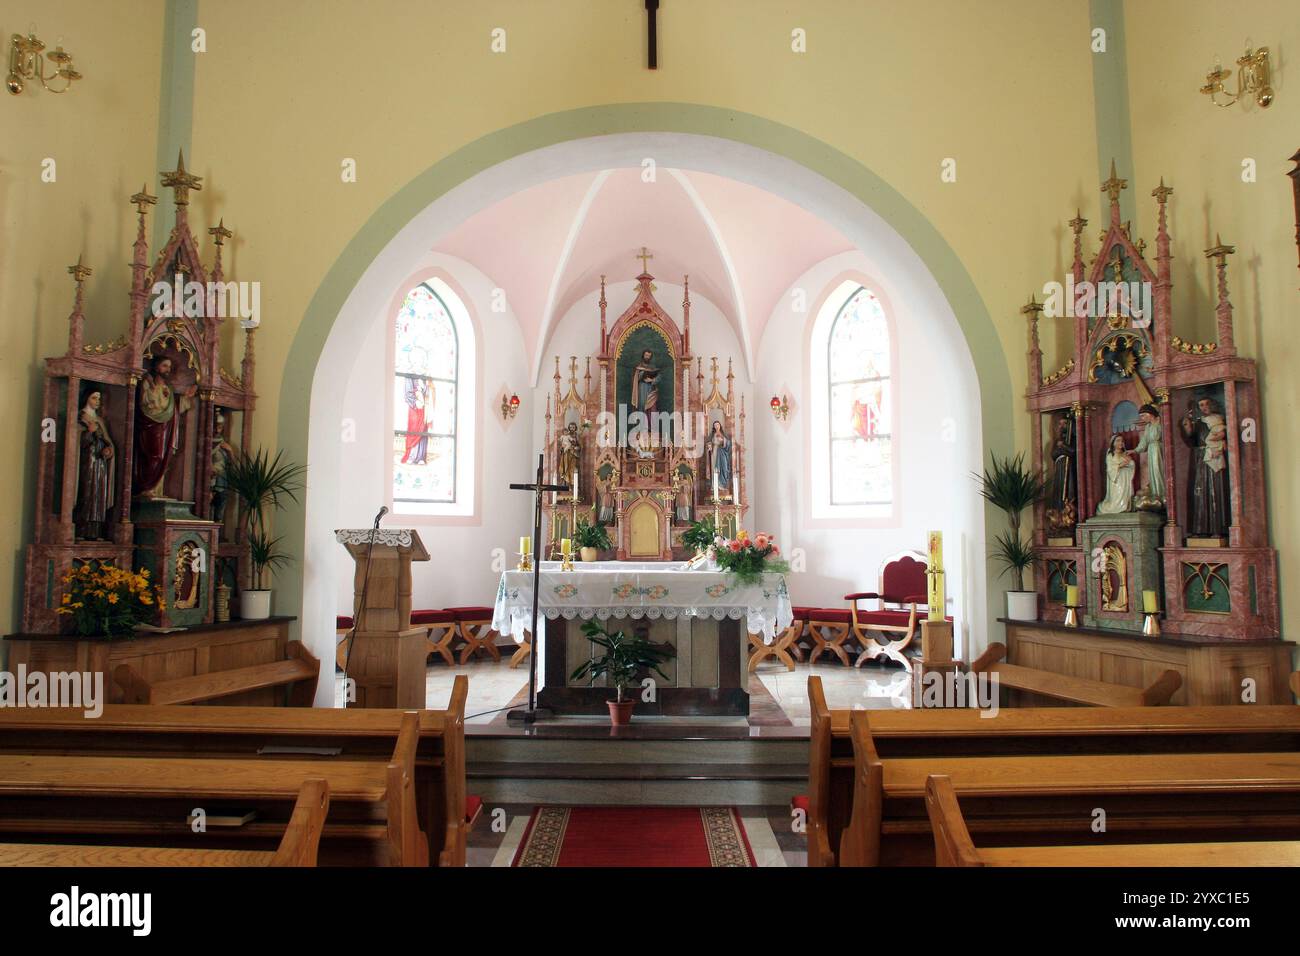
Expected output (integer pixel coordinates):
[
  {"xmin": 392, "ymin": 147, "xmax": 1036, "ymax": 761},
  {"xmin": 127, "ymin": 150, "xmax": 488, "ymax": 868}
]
[{"xmin": 391, "ymin": 282, "xmax": 460, "ymax": 512}]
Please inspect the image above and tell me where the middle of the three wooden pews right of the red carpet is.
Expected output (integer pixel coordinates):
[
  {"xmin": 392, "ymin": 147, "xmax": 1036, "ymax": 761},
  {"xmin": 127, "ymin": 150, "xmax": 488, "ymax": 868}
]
[{"xmin": 837, "ymin": 710, "xmax": 1300, "ymax": 866}]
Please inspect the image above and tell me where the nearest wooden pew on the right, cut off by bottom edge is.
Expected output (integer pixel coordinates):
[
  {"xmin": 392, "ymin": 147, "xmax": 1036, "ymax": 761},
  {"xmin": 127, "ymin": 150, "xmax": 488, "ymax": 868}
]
[{"xmin": 926, "ymin": 774, "xmax": 1300, "ymax": 866}]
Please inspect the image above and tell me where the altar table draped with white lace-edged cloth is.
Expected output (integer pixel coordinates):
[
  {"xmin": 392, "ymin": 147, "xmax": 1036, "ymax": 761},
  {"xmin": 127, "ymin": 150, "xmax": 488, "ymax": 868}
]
[{"xmin": 493, "ymin": 562, "xmax": 793, "ymax": 717}]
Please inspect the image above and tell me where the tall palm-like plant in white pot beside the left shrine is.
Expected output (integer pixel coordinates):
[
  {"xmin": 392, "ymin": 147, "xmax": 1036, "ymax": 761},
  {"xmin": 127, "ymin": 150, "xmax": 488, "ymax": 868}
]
[{"xmin": 226, "ymin": 449, "xmax": 307, "ymax": 620}]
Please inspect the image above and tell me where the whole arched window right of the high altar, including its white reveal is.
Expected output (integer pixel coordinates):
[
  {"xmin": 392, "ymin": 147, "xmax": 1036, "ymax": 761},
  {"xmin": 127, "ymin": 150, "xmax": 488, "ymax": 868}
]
[{"xmin": 813, "ymin": 282, "xmax": 893, "ymax": 516}]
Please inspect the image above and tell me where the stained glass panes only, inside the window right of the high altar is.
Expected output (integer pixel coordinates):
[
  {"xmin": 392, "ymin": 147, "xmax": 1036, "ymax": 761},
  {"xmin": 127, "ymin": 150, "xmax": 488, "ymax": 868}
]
[{"xmin": 827, "ymin": 286, "xmax": 893, "ymax": 506}]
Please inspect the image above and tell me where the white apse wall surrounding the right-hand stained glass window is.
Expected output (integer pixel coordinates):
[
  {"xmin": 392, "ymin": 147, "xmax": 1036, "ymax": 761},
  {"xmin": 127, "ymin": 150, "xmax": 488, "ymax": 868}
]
[{"xmin": 750, "ymin": 252, "xmax": 984, "ymax": 653}]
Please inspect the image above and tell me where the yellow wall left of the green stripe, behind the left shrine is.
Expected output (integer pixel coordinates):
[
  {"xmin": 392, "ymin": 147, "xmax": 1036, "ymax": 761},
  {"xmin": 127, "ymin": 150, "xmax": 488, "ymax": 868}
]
[{"xmin": 0, "ymin": 0, "xmax": 164, "ymax": 642}]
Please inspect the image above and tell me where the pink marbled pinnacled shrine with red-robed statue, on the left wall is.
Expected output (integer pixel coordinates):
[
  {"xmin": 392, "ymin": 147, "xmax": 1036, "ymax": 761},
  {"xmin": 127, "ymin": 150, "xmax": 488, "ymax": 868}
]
[{"xmin": 22, "ymin": 156, "xmax": 256, "ymax": 633}]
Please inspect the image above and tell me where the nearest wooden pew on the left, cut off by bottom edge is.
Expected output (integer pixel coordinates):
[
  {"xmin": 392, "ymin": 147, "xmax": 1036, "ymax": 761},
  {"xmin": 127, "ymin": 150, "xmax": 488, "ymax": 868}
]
[{"xmin": 0, "ymin": 777, "xmax": 329, "ymax": 866}]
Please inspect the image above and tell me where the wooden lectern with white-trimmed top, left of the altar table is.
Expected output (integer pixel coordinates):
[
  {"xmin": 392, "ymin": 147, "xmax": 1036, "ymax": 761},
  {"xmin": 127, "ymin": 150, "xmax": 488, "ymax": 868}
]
[{"xmin": 334, "ymin": 528, "xmax": 429, "ymax": 709}]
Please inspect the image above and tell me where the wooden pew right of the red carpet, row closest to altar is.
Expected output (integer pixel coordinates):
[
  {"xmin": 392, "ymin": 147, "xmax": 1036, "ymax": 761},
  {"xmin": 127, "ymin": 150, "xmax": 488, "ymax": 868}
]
[{"xmin": 806, "ymin": 676, "xmax": 1300, "ymax": 866}]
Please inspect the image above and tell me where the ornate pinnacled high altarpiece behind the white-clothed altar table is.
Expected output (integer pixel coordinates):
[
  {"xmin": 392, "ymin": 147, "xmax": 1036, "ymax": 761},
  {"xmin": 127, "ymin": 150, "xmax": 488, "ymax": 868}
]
[{"xmin": 546, "ymin": 272, "xmax": 746, "ymax": 561}]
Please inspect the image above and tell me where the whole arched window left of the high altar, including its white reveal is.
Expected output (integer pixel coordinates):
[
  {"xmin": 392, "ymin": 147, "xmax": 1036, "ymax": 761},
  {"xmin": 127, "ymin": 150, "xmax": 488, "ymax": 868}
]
[{"xmin": 391, "ymin": 278, "xmax": 473, "ymax": 515}]
